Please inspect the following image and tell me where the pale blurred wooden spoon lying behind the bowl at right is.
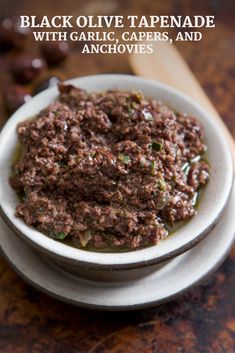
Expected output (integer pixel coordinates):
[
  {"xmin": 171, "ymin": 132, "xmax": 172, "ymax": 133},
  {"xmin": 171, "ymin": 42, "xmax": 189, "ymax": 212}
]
[{"xmin": 130, "ymin": 42, "xmax": 235, "ymax": 166}]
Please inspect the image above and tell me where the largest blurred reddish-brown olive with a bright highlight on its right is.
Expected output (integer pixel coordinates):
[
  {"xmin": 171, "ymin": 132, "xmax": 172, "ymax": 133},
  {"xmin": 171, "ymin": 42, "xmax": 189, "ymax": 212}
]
[{"xmin": 11, "ymin": 54, "xmax": 46, "ymax": 84}]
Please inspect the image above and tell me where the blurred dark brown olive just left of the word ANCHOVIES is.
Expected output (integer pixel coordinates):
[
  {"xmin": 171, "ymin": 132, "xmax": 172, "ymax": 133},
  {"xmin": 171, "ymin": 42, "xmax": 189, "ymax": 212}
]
[{"xmin": 41, "ymin": 42, "xmax": 69, "ymax": 66}]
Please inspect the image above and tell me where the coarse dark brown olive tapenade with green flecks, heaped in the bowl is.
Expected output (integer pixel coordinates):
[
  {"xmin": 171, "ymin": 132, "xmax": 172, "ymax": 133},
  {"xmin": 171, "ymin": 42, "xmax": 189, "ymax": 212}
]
[{"xmin": 10, "ymin": 84, "xmax": 209, "ymax": 251}]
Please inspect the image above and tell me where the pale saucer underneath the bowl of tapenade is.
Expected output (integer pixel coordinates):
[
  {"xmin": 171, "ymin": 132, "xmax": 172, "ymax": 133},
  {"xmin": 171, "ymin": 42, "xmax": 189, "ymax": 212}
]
[{"xmin": 0, "ymin": 184, "xmax": 235, "ymax": 310}]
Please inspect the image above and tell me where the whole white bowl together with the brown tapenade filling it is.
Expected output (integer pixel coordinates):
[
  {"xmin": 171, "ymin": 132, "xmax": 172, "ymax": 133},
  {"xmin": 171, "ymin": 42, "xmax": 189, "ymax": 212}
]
[{"xmin": 0, "ymin": 75, "xmax": 233, "ymax": 276}]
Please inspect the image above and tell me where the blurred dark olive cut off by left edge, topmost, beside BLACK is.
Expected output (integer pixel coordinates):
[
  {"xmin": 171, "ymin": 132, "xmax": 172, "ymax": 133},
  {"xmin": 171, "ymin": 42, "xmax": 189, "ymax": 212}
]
[{"xmin": 0, "ymin": 17, "xmax": 30, "ymax": 52}]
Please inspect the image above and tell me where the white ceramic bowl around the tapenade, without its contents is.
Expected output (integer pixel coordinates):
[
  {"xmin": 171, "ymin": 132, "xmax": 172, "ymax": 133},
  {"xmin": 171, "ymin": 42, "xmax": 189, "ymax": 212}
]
[{"xmin": 0, "ymin": 75, "xmax": 233, "ymax": 278}]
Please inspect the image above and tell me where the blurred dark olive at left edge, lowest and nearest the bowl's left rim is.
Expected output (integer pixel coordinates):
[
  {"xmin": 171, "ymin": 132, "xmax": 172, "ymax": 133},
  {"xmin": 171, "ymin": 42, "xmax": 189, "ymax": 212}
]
[{"xmin": 3, "ymin": 84, "xmax": 31, "ymax": 114}]
